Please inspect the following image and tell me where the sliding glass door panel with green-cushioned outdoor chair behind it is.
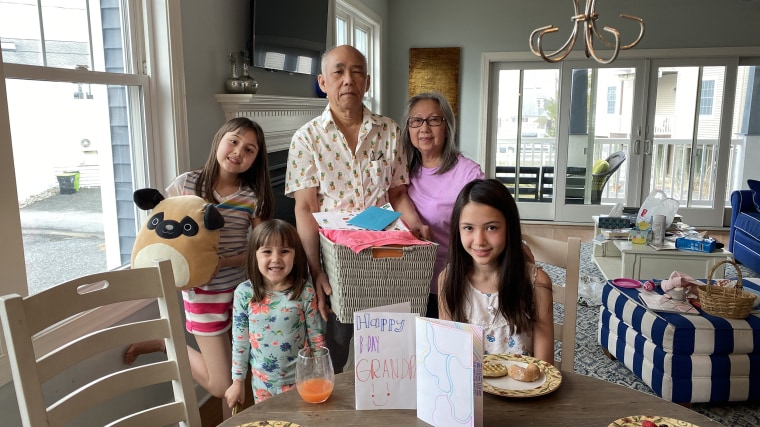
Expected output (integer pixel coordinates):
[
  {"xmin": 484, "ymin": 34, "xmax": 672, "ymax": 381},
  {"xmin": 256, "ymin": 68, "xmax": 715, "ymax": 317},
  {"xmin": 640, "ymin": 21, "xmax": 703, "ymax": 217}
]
[{"xmin": 557, "ymin": 61, "xmax": 644, "ymax": 217}]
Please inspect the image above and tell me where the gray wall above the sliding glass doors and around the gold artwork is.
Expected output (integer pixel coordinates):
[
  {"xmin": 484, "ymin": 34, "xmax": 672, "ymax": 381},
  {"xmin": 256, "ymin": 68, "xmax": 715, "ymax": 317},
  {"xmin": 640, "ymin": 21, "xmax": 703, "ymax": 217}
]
[{"xmin": 384, "ymin": 0, "xmax": 760, "ymax": 157}]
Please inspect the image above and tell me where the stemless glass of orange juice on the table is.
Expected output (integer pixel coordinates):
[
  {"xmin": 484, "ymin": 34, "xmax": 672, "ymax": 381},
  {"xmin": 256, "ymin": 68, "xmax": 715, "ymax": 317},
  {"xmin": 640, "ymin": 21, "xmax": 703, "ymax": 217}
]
[{"xmin": 296, "ymin": 346, "xmax": 335, "ymax": 403}]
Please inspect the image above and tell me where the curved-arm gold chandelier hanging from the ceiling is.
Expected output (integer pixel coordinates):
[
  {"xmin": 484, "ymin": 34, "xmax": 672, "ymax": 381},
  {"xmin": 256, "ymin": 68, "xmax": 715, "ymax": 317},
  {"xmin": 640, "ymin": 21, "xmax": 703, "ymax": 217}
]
[{"xmin": 529, "ymin": 0, "xmax": 644, "ymax": 64}]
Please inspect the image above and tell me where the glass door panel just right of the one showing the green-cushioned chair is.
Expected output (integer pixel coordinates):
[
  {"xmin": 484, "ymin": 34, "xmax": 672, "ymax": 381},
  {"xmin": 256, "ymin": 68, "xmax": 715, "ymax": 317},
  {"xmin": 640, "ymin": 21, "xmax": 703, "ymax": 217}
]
[{"xmin": 634, "ymin": 60, "xmax": 737, "ymax": 226}]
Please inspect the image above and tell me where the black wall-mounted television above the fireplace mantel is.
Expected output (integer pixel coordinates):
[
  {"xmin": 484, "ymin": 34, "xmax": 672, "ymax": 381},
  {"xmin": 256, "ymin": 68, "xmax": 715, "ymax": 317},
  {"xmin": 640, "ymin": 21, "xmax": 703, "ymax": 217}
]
[{"xmin": 251, "ymin": 0, "xmax": 330, "ymax": 75}]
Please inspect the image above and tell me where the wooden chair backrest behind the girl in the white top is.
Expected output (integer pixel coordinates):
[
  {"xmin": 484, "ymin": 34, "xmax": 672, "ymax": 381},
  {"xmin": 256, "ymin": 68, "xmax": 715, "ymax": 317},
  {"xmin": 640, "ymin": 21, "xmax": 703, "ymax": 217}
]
[{"xmin": 523, "ymin": 234, "xmax": 581, "ymax": 372}]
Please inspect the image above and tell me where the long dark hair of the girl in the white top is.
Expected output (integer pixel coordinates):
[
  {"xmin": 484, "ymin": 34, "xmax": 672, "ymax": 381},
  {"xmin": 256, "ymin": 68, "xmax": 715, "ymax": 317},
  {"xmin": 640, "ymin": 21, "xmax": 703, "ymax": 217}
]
[{"xmin": 442, "ymin": 179, "xmax": 535, "ymax": 335}]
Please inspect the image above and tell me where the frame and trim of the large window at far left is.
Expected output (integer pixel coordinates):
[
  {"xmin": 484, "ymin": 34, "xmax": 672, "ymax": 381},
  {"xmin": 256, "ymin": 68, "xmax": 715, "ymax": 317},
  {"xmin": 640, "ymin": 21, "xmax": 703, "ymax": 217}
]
[{"xmin": 0, "ymin": 0, "xmax": 190, "ymax": 387}]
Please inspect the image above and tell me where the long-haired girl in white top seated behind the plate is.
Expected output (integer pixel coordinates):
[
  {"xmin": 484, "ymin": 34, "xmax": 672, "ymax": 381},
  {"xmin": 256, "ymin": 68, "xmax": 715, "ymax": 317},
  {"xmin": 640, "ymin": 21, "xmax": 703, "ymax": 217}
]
[{"xmin": 438, "ymin": 179, "xmax": 554, "ymax": 364}]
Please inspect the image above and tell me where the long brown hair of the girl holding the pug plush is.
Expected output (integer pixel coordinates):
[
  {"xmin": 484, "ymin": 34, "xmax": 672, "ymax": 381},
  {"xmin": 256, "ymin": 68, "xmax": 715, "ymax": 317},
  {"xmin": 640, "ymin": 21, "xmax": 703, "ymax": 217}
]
[{"xmin": 195, "ymin": 117, "xmax": 274, "ymax": 221}]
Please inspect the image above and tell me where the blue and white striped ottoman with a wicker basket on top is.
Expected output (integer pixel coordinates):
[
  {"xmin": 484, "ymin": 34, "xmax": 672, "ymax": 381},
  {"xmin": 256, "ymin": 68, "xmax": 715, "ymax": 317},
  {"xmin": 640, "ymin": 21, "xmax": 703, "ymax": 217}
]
[{"xmin": 598, "ymin": 279, "xmax": 760, "ymax": 403}]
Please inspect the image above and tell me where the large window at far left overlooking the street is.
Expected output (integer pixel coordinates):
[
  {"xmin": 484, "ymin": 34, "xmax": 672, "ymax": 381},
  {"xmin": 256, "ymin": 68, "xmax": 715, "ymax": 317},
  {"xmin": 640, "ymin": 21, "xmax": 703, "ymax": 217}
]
[{"xmin": 0, "ymin": 0, "xmax": 149, "ymax": 293}]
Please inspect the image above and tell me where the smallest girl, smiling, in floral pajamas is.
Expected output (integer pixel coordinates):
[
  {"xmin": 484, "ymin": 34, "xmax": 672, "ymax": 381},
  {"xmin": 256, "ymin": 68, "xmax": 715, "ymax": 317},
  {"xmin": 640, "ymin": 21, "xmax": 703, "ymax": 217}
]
[{"xmin": 224, "ymin": 219, "xmax": 325, "ymax": 408}]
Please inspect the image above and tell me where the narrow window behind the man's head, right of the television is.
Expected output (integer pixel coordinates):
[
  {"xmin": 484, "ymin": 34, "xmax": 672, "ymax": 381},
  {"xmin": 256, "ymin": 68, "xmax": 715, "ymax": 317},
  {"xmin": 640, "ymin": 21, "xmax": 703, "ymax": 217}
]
[{"xmin": 335, "ymin": 0, "xmax": 381, "ymax": 112}]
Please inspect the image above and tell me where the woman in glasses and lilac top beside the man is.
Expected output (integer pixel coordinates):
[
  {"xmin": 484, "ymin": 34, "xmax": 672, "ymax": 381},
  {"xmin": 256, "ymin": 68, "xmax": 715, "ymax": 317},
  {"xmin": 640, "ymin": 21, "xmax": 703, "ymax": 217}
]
[{"xmin": 401, "ymin": 92, "xmax": 485, "ymax": 318}]
